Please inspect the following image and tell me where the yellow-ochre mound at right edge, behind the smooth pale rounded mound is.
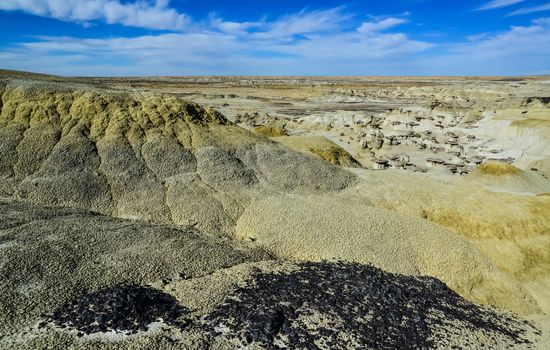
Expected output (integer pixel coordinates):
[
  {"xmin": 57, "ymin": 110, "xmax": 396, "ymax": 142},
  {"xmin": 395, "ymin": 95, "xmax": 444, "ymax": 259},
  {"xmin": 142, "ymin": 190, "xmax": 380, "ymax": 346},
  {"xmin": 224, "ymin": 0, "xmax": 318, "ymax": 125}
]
[{"xmin": 345, "ymin": 171, "xmax": 550, "ymax": 314}]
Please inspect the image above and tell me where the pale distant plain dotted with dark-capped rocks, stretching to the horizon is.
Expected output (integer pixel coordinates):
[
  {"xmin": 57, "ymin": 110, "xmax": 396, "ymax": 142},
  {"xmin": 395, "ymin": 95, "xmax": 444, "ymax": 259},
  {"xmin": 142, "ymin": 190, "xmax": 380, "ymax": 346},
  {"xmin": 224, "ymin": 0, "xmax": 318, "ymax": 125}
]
[{"xmin": 88, "ymin": 77, "xmax": 550, "ymax": 183}]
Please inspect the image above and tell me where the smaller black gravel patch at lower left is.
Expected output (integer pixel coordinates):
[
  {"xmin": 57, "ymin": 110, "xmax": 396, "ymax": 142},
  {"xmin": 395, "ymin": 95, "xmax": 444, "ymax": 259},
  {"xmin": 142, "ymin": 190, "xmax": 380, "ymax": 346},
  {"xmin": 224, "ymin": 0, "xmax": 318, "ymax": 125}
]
[{"xmin": 42, "ymin": 285, "xmax": 187, "ymax": 336}]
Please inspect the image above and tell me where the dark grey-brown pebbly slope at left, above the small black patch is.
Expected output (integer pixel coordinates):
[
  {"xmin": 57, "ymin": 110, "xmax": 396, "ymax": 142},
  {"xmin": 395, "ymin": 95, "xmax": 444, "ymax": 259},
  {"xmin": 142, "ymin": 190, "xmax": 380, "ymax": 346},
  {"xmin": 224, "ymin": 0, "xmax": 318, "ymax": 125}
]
[{"xmin": 0, "ymin": 200, "xmax": 269, "ymax": 336}]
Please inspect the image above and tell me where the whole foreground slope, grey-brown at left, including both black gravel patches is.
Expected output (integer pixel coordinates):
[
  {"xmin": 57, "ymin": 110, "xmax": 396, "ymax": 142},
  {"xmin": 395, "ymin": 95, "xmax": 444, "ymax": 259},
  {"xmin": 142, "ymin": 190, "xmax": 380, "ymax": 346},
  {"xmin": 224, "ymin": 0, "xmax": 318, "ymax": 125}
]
[{"xmin": 0, "ymin": 200, "xmax": 545, "ymax": 349}]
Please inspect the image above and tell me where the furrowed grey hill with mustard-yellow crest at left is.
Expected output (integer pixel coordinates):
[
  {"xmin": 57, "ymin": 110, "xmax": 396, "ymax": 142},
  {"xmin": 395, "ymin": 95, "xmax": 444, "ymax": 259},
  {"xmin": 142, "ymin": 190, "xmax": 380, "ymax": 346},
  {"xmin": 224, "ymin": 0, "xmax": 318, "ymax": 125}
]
[{"xmin": 0, "ymin": 79, "xmax": 354, "ymax": 237}]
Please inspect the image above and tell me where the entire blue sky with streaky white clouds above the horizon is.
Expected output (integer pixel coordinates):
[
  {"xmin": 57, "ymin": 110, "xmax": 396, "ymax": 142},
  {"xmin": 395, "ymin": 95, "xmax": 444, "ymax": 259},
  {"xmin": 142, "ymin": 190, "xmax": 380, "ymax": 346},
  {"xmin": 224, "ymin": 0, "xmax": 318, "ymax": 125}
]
[{"xmin": 0, "ymin": 0, "xmax": 550, "ymax": 76}]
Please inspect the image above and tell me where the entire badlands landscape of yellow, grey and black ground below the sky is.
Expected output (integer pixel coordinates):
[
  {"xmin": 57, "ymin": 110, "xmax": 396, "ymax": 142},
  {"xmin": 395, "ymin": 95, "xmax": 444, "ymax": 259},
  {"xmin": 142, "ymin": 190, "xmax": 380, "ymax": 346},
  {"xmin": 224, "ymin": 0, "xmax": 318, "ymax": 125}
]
[{"xmin": 0, "ymin": 71, "xmax": 550, "ymax": 350}]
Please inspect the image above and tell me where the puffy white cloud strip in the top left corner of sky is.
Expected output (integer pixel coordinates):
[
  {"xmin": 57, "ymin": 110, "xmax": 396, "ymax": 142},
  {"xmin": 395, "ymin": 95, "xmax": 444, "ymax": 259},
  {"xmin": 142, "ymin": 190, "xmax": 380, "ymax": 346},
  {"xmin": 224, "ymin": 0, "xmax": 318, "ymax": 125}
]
[{"xmin": 0, "ymin": 0, "xmax": 189, "ymax": 30}]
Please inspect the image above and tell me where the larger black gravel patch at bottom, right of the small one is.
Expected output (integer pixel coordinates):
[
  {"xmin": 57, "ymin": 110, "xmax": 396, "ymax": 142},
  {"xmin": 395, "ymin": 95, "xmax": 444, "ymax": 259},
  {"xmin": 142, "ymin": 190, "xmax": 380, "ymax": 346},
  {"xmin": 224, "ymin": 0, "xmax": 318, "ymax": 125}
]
[{"xmin": 202, "ymin": 262, "xmax": 538, "ymax": 349}]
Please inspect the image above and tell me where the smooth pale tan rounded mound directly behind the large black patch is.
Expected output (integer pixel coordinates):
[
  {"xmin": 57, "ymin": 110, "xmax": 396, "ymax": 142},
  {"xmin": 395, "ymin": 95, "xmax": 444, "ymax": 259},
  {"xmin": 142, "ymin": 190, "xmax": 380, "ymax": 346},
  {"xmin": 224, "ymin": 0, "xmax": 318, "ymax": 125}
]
[{"xmin": 236, "ymin": 195, "xmax": 540, "ymax": 314}]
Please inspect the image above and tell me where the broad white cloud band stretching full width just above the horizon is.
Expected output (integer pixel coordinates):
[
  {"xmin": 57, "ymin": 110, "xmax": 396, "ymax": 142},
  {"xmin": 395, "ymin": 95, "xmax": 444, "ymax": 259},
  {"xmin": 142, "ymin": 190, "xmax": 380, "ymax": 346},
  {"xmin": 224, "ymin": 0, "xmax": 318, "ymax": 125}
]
[{"xmin": 0, "ymin": 9, "xmax": 550, "ymax": 75}]
